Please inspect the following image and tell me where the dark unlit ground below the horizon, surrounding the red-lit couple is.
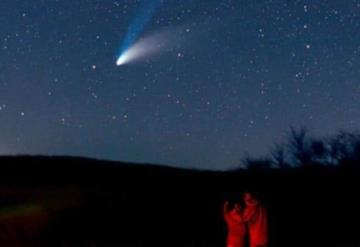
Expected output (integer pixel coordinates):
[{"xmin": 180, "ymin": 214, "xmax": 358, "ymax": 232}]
[{"xmin": 0, "ymin": 157, "xmax": 360, "ymax": 247}]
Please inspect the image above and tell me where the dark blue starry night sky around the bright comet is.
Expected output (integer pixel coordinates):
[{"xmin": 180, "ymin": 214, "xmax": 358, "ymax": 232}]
[{"xmin": 0, "ymin": 0, "xmax": 360, "ymax": 169}]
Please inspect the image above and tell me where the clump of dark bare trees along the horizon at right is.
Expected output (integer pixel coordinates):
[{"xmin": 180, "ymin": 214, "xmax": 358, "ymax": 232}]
[{"xmin": 241, "ymin": 127, "xmax": 360, "ymax": 169}]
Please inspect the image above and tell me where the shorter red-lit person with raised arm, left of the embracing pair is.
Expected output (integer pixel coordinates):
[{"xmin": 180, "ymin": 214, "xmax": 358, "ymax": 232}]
[{"xmin": 224, "ymin": 202, "xmax": 246, "ymax": 247}]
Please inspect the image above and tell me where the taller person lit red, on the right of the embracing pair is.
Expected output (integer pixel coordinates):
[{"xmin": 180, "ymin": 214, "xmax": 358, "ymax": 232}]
[{"xmin": 242, "ymin": 192, "xmax": 269, "ymax": 247}]
